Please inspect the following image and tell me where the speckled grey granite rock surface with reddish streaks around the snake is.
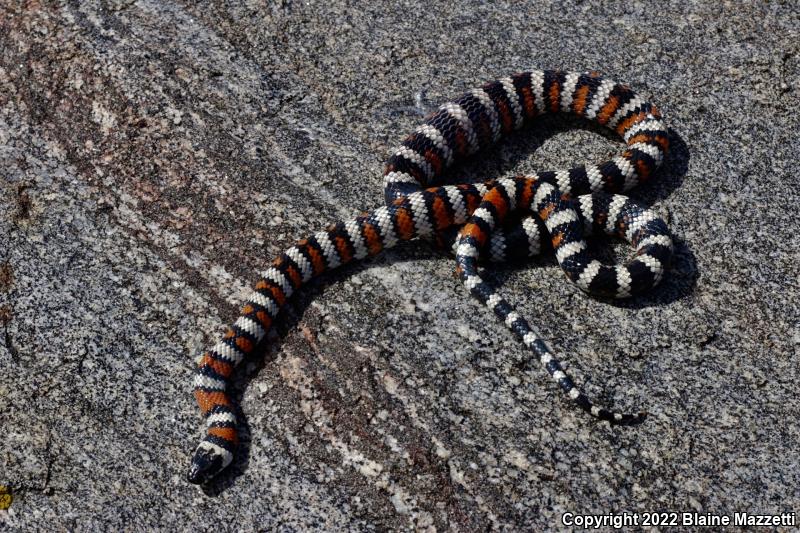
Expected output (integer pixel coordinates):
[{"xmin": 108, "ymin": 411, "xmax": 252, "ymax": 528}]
[{"xmin": 0, "ymin": 0, "xmax": 800, "ymax": 531}]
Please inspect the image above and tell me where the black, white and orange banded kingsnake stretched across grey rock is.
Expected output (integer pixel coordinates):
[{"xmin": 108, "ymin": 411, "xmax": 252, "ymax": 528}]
[{"xmin": 188, "ymin": 70, "xmax": 672, "ymax": 483}]
